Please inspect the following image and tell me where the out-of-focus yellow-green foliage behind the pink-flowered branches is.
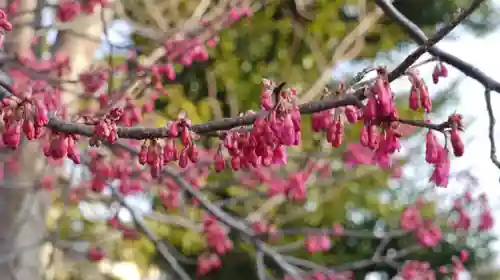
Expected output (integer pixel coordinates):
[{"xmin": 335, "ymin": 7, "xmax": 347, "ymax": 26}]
[{"xmin": 52, "ymin": 0, "xmax": 498, "ymax": 280}]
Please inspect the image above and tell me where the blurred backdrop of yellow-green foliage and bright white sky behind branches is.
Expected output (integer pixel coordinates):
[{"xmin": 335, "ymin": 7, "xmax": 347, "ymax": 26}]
[{"xmin": 2, "ymin": 0, "xmax": 500, "ymax": 280}]
